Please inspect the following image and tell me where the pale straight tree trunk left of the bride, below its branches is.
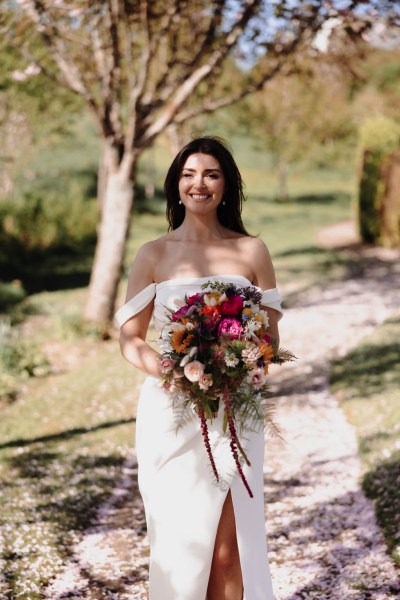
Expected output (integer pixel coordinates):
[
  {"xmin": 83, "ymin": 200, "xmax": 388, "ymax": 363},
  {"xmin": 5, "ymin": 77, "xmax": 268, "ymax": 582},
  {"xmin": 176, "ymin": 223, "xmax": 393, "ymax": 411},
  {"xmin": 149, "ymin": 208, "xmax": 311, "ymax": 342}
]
[{"xmin": 85, "ymin": 160, "xmax": 136, "ymax": 327}]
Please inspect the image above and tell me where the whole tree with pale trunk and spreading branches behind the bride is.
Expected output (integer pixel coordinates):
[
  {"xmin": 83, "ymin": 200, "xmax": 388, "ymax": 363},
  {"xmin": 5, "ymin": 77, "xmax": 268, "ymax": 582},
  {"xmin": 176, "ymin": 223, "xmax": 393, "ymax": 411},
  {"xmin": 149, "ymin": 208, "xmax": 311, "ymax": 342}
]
[{"xmin": 2, "ymin": 0, "xmax": 396, "ymax": 323}]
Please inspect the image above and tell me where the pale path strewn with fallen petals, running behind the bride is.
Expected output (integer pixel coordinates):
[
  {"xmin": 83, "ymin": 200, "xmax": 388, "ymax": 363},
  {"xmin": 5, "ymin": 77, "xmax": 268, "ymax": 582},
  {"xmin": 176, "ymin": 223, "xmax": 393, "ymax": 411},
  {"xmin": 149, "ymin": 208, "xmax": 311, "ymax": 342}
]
[{"xmin": 47, "ymin": 246, "xmax": 400, "ymax": 600}]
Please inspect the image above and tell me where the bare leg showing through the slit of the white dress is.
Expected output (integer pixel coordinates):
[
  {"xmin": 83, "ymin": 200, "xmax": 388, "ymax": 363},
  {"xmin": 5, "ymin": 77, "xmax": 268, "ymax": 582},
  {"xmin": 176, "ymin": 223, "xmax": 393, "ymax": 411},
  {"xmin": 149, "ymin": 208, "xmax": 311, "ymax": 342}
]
[{"xmin": 207, "ymin": 492, "xmax": 243, "ymax": 600}]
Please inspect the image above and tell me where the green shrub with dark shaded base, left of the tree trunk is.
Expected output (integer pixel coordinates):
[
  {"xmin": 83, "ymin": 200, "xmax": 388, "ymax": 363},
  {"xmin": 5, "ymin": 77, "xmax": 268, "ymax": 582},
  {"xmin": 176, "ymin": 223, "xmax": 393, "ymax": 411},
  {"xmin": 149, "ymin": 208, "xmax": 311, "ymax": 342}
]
[{"xmin": 0, "ymin": 190, "xmax": 98, "ymax": 291}]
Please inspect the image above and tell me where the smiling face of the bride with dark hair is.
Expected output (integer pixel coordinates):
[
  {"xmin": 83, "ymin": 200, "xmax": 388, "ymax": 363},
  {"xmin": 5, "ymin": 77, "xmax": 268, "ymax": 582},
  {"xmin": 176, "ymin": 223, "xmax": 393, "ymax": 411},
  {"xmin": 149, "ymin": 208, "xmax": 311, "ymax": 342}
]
[{"xmin": 179, "ymin": 153, "xmax": 225, "ymax": 214}]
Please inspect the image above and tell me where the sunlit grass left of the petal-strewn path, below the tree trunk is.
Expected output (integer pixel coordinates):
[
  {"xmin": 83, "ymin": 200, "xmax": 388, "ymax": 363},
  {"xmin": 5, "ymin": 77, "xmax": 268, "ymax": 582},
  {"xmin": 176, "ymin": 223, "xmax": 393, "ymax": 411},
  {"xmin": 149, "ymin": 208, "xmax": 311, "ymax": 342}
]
[{"xmin": 0, "ymin": 290, "xmax": 143, "ymax": 600}]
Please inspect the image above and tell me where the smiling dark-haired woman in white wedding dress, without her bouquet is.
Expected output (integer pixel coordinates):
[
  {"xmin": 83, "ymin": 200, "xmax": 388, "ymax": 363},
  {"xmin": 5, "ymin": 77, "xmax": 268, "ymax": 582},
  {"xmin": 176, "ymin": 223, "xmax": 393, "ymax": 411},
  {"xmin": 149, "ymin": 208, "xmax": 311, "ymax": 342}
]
[{"xmin": 117, "ymin": 137, "xmax": 281, "ymax": 600}]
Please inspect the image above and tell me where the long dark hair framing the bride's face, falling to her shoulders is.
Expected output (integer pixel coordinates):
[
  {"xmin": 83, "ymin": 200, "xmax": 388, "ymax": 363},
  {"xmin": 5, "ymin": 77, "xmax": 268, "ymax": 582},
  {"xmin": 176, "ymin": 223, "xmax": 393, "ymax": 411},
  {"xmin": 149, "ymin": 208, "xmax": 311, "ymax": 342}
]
[{"xmin": 164, "ymin": 136, "xmax": 250, "ymax": 235}]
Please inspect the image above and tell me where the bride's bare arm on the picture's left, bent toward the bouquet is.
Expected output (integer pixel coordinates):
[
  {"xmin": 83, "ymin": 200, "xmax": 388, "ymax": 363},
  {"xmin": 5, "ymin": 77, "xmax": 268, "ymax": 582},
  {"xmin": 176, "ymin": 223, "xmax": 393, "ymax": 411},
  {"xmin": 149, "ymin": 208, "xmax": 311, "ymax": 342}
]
[{"xmin": 119, "ymin": 244, "xmax": 161, "ymax": 377}]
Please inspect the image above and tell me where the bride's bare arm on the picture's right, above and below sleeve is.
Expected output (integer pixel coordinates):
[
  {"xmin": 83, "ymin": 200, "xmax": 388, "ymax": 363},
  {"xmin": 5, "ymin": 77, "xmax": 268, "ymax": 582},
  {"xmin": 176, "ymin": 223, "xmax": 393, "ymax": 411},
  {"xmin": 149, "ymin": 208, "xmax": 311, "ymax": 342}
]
[{"xmin": 248, "ymin": 238, "xmax": 282, "ymax": 346}]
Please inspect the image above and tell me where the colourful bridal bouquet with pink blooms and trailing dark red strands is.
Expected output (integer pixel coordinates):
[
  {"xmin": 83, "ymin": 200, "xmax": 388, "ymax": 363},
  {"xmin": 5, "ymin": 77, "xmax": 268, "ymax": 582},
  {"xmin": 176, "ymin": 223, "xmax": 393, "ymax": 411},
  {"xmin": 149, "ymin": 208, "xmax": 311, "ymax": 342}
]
[{"xmin": 161, "ymin": 281, "xmax": 294, "ymax": 497}]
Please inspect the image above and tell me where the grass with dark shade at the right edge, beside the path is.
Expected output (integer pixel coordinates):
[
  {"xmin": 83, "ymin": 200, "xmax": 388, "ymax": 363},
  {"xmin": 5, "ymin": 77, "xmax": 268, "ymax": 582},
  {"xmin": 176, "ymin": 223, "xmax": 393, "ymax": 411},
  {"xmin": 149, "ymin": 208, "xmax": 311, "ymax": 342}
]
[{"xmin": 331, "ymin": 313, "xmax": 400, "ymax": 565}]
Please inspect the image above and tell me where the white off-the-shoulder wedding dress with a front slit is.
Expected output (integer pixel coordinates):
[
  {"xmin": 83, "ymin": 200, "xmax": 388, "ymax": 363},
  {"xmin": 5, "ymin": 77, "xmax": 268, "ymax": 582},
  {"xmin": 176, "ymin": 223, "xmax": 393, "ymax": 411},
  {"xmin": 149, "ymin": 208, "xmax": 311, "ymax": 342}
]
[{"xmin": 116, "ymin": 275, "xmax": 281, "ymax": 600}]
